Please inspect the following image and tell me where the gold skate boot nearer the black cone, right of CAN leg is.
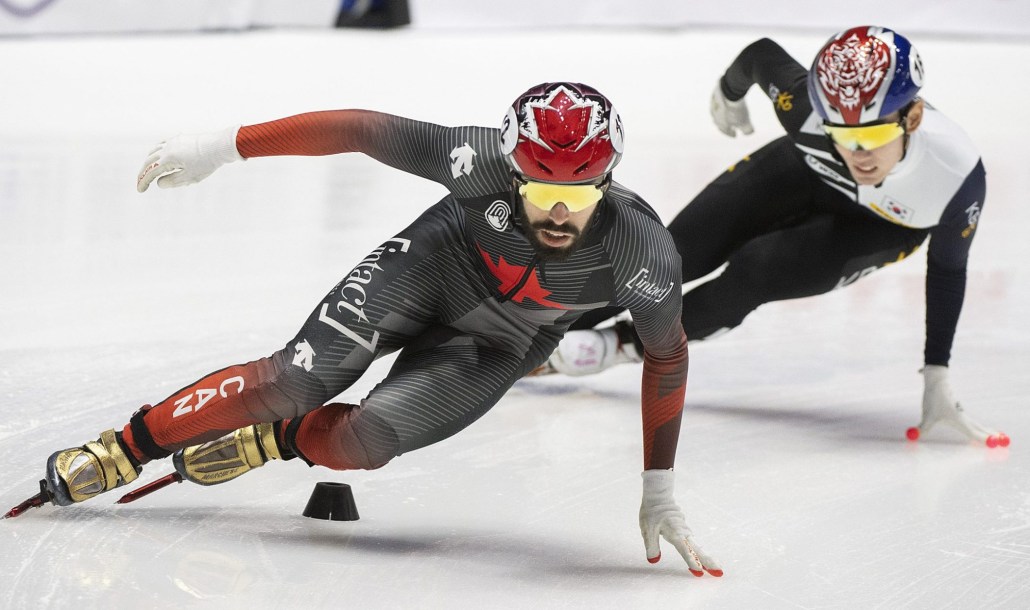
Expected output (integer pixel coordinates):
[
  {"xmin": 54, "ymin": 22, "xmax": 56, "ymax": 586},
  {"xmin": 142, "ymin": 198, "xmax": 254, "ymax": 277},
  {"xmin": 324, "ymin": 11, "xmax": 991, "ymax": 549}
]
[{"xmin": 172, "ymin": 423, "xmax": 282, "ymax": 485}]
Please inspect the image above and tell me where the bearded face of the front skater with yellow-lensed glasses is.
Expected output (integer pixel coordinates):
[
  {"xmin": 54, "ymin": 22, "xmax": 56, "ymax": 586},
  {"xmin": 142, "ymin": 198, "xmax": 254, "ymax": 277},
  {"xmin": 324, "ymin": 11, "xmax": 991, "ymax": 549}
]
[{"xmin": 518, "ymin": 177, "xmax": 607, "ymax": 261}]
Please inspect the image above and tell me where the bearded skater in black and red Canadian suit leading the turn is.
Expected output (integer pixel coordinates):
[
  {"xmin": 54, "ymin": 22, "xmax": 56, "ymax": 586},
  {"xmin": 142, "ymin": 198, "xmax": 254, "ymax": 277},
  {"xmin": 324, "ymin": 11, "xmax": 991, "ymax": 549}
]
[{"xmin": 26, "ymin": 82, "xmax": 722, "ymax": 576}]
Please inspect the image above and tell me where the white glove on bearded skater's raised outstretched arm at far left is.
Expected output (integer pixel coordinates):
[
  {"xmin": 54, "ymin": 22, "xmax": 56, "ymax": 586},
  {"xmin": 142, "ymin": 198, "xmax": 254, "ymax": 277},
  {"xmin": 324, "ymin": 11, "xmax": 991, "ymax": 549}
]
[{"xmin": 136, "ymin": 125, "xmax": 243, "ymax": 193}]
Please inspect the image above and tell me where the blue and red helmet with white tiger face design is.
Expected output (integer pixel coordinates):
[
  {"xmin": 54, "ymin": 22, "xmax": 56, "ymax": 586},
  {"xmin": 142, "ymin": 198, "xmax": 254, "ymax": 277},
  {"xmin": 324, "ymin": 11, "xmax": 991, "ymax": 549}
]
[{"xmin": 809, "ymin": 26, "xmax": 923, "ymax": 125}]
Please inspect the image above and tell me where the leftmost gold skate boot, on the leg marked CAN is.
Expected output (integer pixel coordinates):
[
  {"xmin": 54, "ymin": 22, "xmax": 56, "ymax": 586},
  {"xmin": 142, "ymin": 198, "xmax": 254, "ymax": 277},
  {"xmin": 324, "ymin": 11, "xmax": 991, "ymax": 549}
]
[{"xmin": 43, "ymin": 430, "xmax": 142, "ymax": 506}]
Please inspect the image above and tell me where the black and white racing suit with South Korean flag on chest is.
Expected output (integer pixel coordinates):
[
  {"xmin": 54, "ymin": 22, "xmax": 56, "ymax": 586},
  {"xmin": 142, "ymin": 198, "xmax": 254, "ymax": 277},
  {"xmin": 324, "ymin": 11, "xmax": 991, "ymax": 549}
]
[{"xmin": 574, "ymin": 39, "xmax": 986, "ymax": 365}]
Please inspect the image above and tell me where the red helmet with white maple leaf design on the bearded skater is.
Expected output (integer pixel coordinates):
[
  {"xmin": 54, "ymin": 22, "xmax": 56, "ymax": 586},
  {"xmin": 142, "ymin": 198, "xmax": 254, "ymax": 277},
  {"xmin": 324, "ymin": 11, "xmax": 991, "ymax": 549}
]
[{"xmin": 501, "ymin": 82, "xmax": 623, "ymax": 183}]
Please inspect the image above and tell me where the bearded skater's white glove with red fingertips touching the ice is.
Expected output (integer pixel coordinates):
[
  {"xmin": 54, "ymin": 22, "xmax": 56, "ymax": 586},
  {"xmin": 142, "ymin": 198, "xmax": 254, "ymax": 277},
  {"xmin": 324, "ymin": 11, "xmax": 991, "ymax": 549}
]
[{"xmin": 641, "ymin": 470, "xmax": 722, "ymax": 576}]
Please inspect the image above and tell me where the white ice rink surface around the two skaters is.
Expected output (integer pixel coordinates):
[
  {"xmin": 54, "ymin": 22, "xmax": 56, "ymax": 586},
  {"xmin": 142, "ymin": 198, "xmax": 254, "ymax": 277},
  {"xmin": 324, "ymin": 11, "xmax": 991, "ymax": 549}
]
[{"xmin": 0, "ymin": 24, "xmax": 1030, "ymax": 609}]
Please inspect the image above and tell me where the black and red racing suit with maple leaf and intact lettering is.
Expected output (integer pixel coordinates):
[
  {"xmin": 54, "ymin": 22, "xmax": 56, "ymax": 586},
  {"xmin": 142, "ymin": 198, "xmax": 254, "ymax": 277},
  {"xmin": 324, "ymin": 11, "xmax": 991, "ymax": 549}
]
[{"xmin": 124, "ymin": 110, "xmax": 687, "ymax": 469}]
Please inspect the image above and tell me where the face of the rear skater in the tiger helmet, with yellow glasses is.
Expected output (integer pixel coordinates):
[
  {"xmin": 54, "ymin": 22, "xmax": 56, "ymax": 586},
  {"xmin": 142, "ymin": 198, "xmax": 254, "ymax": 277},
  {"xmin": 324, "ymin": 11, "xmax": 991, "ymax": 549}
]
[{"xmin": 826, "ymin": 101, "xmax": 923, "ymax": 184}]
